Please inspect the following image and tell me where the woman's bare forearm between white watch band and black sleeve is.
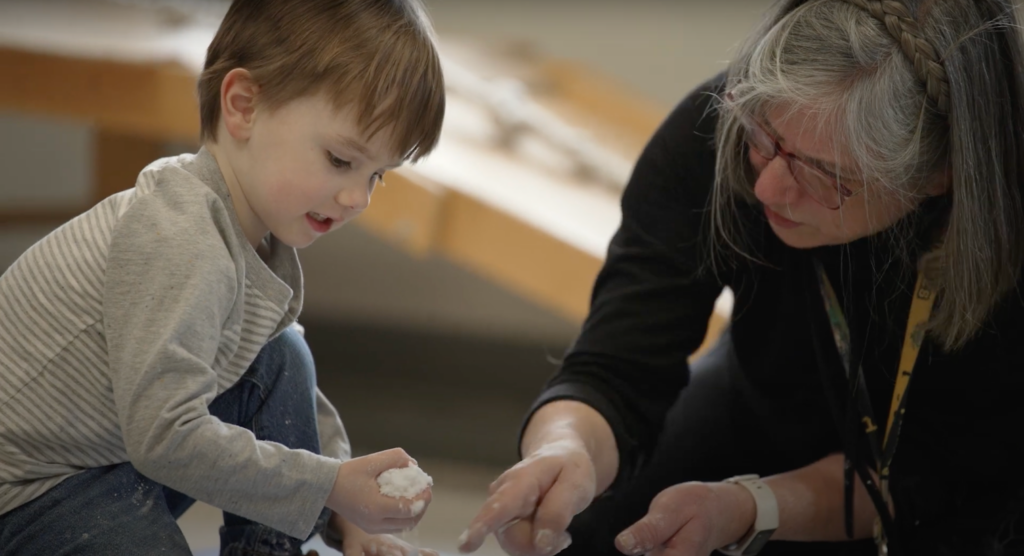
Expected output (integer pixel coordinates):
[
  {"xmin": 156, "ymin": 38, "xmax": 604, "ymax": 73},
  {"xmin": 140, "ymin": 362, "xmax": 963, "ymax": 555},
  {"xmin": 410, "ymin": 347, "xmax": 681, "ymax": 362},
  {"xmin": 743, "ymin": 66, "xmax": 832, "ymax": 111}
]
[{"xmin": 764, "ymin": 454, "xmax": 878, "ymax": 541}]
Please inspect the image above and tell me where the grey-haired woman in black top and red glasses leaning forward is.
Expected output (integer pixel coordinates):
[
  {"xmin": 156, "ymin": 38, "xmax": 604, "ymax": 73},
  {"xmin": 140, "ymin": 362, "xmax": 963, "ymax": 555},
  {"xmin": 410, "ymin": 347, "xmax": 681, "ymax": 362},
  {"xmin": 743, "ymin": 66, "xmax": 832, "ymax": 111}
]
[{"xmin": 461, "ymin": 0, "xmax": 1024, "ymax": 556}]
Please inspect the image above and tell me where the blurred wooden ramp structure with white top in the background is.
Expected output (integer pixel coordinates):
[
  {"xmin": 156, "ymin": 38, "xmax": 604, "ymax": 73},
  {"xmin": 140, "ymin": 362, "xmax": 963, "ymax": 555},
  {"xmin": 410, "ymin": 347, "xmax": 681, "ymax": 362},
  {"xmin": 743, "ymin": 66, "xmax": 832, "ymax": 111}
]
[{"xmin": 0, "ymin": 0, "xmax": 731, "ymax": 356}]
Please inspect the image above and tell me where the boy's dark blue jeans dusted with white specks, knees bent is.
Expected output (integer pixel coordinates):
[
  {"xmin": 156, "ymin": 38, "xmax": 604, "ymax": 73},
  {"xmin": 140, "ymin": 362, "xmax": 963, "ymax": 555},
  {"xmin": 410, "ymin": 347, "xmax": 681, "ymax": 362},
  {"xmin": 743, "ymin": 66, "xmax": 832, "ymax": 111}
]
[{"xmin": 0, "ymin": 329, "xmax": 330, "ymax": 556}]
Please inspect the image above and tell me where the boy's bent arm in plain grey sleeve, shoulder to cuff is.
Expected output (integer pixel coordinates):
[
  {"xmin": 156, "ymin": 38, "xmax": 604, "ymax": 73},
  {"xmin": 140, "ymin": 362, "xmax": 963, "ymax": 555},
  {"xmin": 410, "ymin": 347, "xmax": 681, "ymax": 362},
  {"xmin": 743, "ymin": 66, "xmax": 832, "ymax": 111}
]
[{"xmin": 102, "ymin": 183, "xmax": 340, "ymax": 538}]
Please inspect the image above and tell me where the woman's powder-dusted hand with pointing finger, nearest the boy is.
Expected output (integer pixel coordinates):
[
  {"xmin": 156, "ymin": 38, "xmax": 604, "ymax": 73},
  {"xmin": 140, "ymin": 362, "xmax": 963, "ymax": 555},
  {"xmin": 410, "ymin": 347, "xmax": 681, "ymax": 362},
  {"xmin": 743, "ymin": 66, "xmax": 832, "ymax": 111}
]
[{"xmin": 459, "ymin": 438, "xmax": 597, "ymax": 556}]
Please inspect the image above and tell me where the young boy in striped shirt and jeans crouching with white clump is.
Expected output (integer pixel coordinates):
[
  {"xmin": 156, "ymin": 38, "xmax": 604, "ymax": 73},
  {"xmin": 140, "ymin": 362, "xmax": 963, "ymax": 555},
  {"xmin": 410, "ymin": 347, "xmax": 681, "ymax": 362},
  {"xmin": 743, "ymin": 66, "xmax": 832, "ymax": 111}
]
[{"xmin": 0, "ymin": 0, "xmax": 444, "ymax": 556}]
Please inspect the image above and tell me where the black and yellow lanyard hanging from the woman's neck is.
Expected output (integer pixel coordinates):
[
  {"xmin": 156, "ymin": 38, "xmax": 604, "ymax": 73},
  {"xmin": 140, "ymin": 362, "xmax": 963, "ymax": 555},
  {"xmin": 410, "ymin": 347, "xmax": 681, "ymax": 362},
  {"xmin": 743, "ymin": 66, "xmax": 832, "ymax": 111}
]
[{"xmin": 816, "ymin": 263, "xmax": 935, "ymax": 555}]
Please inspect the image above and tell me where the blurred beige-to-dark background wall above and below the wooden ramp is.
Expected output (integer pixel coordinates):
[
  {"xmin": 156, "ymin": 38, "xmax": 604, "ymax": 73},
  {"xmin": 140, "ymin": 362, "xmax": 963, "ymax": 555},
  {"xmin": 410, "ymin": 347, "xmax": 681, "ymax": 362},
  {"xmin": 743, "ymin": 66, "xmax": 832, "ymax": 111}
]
[{"xmin": 0, "ymin": 0, "xmax": 769, "ymax": 465}]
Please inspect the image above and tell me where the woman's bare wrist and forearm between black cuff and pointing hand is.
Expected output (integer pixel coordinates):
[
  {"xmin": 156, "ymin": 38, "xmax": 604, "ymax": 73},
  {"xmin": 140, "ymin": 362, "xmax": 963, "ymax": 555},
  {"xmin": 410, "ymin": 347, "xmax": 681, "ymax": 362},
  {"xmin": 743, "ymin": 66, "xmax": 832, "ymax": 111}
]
[{"xmin": 520, "ymin": 399, "xmax": 618, "ymax": 493}]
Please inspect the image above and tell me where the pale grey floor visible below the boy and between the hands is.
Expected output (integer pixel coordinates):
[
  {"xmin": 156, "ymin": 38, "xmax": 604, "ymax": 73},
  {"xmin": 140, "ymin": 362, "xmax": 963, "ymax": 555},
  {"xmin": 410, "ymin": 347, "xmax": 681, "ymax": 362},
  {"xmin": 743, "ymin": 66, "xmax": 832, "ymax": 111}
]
[{"xmin": 178, "ymin": 459, "xmax": 504, "ymax": 556}]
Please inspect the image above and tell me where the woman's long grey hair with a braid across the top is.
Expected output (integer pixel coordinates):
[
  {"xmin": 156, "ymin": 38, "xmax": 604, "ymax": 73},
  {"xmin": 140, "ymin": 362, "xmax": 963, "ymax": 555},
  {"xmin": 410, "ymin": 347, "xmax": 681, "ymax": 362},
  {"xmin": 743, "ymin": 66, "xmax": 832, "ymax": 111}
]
[{"xmin": 711, "ymin": 0, "xmax": 1024, "ymax": 350}]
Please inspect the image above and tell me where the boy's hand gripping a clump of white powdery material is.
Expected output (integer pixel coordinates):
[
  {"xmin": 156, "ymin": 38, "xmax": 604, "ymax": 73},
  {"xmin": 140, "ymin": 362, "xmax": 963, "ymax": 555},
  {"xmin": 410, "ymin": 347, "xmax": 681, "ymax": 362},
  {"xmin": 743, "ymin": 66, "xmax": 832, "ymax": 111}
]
[{"xmin": 327, "ymin": 448, "xmax": 431, "ymax": 533}]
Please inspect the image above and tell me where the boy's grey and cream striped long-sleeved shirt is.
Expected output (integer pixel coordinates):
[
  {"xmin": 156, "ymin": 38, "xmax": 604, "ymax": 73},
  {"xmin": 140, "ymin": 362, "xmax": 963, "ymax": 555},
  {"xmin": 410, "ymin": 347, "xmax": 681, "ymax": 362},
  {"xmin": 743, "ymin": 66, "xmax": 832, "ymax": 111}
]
[{"xmin": 0, "ymin": 148, "xmax": 349, "ymax": 538}]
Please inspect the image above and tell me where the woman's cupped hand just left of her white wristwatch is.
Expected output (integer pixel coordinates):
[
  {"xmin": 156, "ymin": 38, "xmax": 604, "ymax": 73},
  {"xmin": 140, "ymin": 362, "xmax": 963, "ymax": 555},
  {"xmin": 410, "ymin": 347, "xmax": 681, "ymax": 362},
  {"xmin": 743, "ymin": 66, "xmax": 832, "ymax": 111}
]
[{"xmin": 615, "ymin": 482, "xmax": 757, "ymax": 556}]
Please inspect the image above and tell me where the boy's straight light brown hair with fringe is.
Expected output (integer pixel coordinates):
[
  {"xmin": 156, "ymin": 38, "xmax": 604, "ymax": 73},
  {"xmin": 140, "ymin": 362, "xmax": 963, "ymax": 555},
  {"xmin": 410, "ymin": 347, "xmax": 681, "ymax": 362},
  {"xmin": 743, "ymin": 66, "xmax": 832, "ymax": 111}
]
[{"xmin": 199, "ymin": 0, "xmax": 444, "ymax": 161}]
